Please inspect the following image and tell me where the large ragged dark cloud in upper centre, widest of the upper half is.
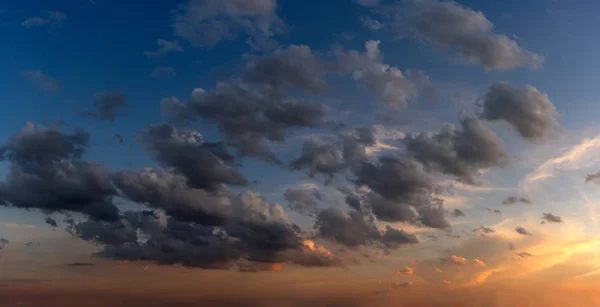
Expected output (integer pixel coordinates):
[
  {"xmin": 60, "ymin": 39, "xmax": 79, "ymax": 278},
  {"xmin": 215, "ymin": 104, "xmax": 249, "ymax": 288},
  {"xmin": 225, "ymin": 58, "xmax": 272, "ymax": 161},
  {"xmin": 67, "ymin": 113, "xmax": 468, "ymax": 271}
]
[{"xmin": 161, "ymin": 46, "xmax": 325, "ymax": 164}]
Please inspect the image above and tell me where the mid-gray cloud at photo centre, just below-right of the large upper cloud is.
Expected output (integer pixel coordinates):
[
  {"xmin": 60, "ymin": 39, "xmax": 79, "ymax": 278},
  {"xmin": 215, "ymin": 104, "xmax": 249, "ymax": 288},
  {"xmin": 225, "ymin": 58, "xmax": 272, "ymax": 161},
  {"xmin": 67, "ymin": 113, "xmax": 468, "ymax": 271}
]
[{"xmin": 290, "ymin": 127, "xmax": 376, "ymax": 180}]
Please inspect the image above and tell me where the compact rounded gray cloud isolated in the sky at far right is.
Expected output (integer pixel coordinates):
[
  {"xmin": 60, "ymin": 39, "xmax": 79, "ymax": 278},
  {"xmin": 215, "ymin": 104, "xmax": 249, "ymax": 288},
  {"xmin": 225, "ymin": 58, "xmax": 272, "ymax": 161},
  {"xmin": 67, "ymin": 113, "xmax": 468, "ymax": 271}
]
[{"xmin": 481, "ymin": 82, "xmax": 558, "ymax": 142}]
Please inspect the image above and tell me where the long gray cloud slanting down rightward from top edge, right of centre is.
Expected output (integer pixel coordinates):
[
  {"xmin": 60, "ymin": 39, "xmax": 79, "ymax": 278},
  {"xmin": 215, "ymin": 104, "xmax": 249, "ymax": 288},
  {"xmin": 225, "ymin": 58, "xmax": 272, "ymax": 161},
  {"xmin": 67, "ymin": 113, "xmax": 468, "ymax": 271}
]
[{"xmin": 392, "ymin": 0, "xmax": 544, "ymax": 70}]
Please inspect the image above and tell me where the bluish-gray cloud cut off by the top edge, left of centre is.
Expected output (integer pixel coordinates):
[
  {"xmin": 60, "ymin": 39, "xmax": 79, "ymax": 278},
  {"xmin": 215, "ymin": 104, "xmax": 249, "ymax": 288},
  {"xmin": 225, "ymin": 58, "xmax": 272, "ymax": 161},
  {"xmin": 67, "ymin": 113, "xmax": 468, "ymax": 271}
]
[{"xmin": 173, "ymin": 0, "xmax": 284, "ymax": 47}]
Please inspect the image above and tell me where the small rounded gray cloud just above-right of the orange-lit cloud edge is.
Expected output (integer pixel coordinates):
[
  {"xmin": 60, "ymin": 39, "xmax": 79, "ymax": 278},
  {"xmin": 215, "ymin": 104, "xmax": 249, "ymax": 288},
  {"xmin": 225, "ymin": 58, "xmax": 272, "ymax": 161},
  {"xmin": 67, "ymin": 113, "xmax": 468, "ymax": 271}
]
[{"xmin": 315, "ymin": 208, "xmax": 382, "ymax": 247}]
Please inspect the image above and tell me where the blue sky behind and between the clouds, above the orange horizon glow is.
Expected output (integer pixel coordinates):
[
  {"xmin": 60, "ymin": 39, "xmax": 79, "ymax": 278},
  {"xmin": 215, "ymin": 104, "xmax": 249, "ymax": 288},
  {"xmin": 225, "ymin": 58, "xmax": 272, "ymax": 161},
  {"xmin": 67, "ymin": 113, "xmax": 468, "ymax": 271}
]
[{"xmin": 0, "ymin": 0, "xmax": 600, "ymax": 306}]
